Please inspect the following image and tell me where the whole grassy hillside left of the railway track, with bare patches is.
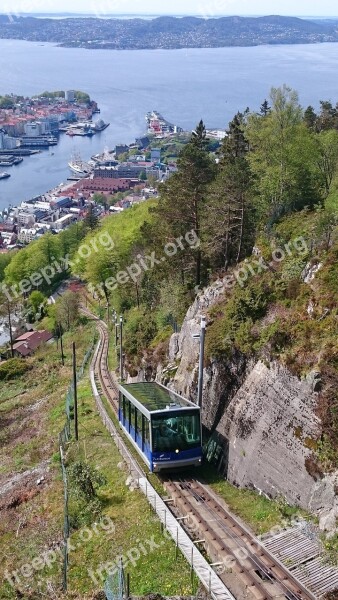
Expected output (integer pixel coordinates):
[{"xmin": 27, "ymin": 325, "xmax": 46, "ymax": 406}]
[{"xmin": 0, "ymin": 319, "xmax": 196, "ymax": 600}]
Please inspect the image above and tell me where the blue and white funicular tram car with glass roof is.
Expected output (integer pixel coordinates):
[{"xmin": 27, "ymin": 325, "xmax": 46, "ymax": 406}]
[{"xmin": 119, "ymin": 382, "xmax": 202, "ymax": 472}]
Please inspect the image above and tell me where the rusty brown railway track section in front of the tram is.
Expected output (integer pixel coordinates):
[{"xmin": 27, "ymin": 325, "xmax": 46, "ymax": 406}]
[{"xmin": 164, "ymin": 477, "xmax": 316, "ymax": 600}]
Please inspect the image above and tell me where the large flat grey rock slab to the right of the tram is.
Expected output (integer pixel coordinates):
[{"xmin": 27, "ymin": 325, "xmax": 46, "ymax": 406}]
[{"xmin": 217, "ymin": 362, "xmax": 320, "ymax": 508}]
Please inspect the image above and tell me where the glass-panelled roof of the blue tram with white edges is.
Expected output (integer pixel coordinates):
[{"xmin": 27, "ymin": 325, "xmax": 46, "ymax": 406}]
[{"xmin": 119, "ymin": 382, "xmax": 198, "ymax": 413}]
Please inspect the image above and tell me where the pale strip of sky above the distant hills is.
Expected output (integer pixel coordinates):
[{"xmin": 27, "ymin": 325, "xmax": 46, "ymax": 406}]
[{"xmin": 0, "ymin": 0, "xmax": 338, "ymax": 17}]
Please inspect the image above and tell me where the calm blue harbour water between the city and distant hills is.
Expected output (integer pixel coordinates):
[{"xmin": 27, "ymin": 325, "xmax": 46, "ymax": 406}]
[{"xmin": 0, "ymin": 40, "xmax": 338, "ymax": 210}]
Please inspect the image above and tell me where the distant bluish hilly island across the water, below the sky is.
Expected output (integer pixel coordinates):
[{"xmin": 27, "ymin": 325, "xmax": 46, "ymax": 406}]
[{"xmin": 0, "ymin": 15, "xmax": 338, "ymax": 50}]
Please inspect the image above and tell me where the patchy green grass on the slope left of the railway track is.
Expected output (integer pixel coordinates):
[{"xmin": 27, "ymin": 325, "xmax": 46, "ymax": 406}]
[{"xmin": 0, "ymin": 326, "xmax": 195, "ymax": 599}]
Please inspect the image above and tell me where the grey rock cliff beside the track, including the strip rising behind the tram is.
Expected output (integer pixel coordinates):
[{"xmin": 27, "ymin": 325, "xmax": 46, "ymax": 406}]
[{"xmin": 162, "ymin": 281, "xmax": 338, "ymax": 529}]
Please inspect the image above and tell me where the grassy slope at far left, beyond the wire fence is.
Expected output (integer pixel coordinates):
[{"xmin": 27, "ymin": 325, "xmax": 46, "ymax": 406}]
[{"xmin": 0, "ymin": 323, "xmax": 94, "ymax": 599}]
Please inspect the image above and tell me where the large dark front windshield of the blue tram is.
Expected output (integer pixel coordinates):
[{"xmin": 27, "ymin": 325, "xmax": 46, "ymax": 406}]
[{"xmin": 152, "ymin": 411, "xmax": 201, "ymax": 452}]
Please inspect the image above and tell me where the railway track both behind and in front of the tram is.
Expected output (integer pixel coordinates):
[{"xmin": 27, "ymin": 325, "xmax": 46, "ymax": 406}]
[{"xmin": 82, "ymin": 308, "xmax": 330, "ymax": 600}]
